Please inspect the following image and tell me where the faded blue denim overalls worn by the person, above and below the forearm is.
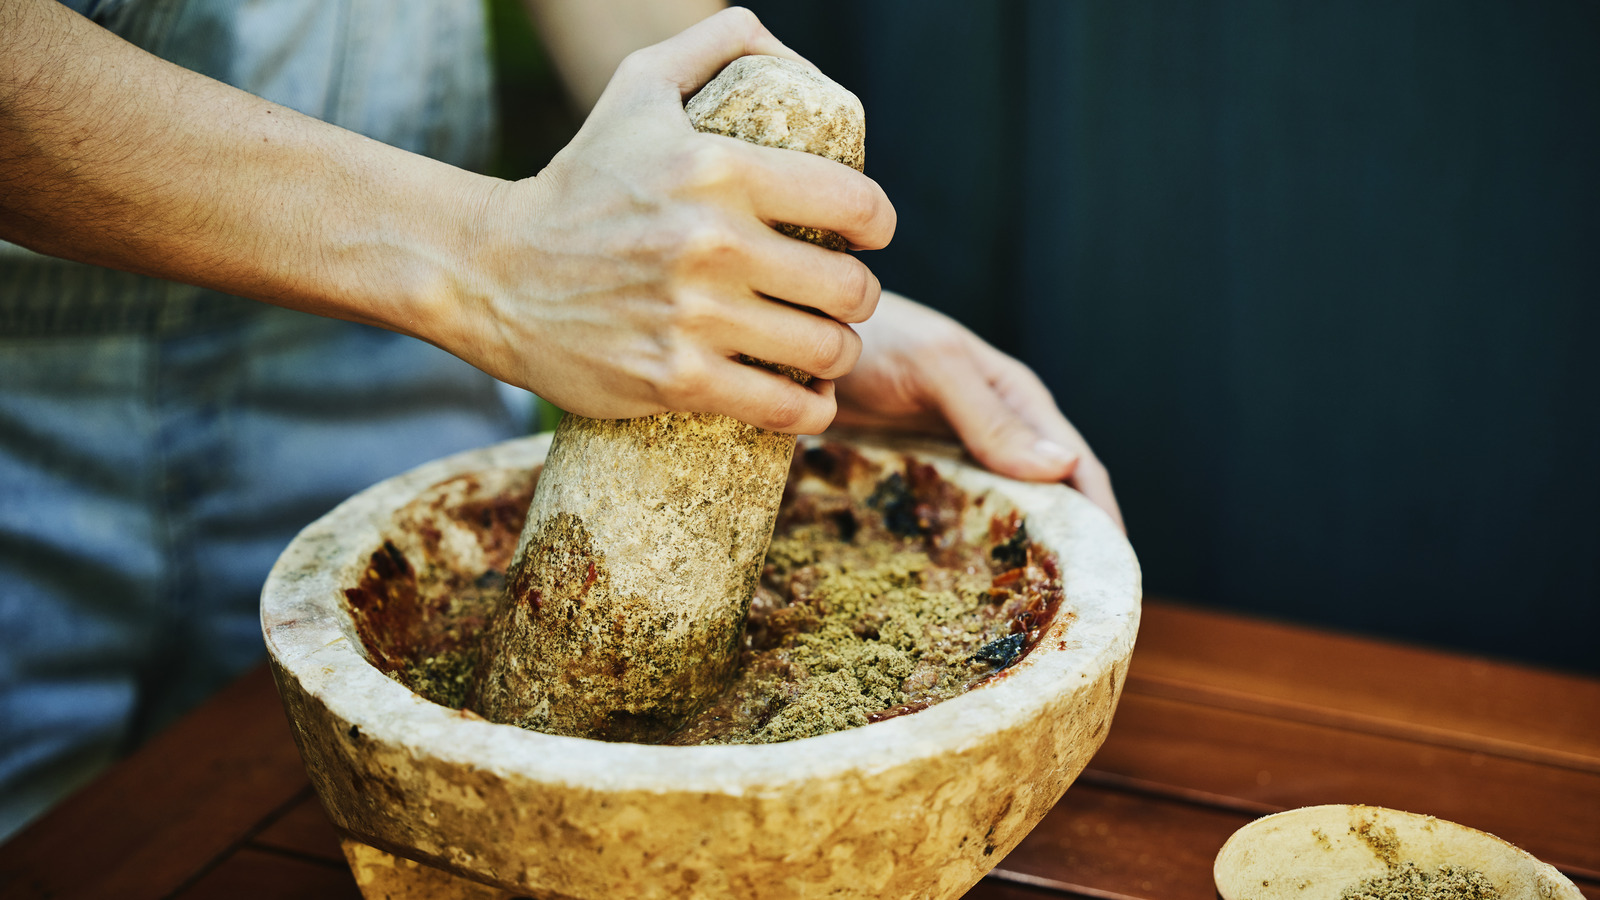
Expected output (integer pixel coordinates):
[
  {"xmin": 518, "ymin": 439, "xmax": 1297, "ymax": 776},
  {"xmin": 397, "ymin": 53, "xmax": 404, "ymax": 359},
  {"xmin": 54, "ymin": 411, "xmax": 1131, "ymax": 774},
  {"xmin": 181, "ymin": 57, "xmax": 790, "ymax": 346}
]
[{"xmin": 0, "ymin": 0, "xmax": 518, "ymax": 839}]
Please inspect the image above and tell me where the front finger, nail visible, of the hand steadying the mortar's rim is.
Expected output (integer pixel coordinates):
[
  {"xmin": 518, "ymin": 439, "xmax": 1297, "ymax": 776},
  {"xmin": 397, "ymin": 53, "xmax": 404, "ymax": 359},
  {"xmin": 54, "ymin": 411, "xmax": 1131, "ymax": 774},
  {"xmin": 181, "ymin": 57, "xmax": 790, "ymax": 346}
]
[{"xmin": 928, "ymin": 352, "xmax": 1078, "ymax": 482}]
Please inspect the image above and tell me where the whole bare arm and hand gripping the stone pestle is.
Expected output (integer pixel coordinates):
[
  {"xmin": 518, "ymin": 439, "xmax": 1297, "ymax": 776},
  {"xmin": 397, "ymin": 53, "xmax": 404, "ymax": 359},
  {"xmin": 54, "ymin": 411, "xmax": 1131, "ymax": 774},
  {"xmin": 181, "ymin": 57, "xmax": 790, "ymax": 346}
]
[{"xmin": 0, "ymin": 0, "xmax": 894, "ymax": 431}]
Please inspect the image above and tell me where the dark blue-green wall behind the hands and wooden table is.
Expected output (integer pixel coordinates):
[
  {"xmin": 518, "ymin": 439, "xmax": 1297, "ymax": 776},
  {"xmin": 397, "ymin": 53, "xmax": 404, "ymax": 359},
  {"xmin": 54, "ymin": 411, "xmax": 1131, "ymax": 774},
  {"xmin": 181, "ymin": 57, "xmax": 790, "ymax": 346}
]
[{"xmin": 492, "ymin": 0, "xmax": 1600, "ymax": 671}]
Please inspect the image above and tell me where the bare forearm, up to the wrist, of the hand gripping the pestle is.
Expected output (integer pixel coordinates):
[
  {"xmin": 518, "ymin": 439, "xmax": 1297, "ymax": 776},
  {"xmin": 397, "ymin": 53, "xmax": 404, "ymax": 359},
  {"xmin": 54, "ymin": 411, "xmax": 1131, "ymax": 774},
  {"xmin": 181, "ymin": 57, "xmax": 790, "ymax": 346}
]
[{"xmin": 0, "ymin": 0, "xmax": 496, "ymax": 341}]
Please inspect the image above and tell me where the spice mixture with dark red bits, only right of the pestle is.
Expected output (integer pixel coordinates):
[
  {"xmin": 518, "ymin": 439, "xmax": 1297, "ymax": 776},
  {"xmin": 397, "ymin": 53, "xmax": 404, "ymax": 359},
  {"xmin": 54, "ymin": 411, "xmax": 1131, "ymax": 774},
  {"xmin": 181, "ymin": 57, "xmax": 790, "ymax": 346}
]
[{"xmin": 669, "ymin": 448, "xmax": 1061, "ymax": 745}]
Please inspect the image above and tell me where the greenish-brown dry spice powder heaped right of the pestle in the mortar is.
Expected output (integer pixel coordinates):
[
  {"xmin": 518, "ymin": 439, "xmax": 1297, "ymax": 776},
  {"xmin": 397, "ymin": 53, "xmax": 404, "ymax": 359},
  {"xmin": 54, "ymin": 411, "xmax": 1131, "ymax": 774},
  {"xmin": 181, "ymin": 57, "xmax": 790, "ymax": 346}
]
[{"xmin": 670, "ymin": 525, "xmax": 1053, "ymax": 743}]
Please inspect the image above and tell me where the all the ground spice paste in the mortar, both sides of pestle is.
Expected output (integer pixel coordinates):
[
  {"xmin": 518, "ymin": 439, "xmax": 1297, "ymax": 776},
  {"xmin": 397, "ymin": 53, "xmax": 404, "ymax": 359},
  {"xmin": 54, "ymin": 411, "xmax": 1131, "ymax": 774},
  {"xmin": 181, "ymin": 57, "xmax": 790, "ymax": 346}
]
[{"xmin": 346, "ymin": 444, "xmax": 1066, "ymax": 745}]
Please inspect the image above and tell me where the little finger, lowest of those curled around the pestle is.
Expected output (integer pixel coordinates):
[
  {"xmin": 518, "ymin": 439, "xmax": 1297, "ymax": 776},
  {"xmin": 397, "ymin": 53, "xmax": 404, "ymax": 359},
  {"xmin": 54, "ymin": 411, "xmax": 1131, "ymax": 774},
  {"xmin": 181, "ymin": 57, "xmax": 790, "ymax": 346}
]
[{"xmin": 667, "ymin": 357, "xmax": 837, "ymax": 434}]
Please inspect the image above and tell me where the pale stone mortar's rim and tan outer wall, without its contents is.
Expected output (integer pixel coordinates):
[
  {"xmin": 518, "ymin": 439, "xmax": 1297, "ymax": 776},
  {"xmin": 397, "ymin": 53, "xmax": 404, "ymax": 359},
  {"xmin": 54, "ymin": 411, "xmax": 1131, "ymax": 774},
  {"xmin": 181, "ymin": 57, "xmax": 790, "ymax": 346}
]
[{"xmin": 262, "ymin": 437, "xmax": 1139, "ymax": 900}]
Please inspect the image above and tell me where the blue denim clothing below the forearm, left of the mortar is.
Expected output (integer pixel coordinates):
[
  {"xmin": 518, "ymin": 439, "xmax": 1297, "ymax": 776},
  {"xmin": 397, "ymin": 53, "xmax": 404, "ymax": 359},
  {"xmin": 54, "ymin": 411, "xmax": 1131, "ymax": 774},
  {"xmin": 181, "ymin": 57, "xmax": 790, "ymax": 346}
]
[{"xmin": 0, "ymin": 309, "xmax": 517, "ymax": 831}]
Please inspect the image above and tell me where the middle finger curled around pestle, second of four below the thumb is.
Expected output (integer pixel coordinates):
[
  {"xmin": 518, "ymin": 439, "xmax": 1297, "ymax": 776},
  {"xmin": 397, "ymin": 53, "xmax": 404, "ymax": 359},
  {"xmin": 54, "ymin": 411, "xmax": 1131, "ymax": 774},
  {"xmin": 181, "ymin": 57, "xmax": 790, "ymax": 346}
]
[{"xmin": 747, "ymin": 219, "xmax": 883, "ymax": 322}]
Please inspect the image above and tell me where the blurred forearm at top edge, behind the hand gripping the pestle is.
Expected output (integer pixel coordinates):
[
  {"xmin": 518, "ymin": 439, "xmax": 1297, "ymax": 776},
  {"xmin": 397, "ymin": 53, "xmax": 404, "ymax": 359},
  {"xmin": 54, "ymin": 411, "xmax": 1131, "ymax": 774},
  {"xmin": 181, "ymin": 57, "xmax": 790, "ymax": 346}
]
[{"xmin": 523, "ymin": 0, "xmax": 726, "ymax": 112}]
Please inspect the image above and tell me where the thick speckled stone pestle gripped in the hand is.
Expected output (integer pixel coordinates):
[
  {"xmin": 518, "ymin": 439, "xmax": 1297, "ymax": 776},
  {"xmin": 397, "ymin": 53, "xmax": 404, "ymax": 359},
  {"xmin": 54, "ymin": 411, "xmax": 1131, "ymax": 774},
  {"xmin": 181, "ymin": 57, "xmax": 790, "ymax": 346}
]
[{"xmin": 469, "ymin": 56, "xmax": 866, "ymax": 743}]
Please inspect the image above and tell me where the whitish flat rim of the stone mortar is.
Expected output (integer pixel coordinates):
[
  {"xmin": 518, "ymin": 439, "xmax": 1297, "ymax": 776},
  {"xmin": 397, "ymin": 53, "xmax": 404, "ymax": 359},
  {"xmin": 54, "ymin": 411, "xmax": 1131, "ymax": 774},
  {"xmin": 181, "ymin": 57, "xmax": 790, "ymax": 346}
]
[{"xmin": 261, "ymin": 434, "xmax": 1141, "ymax": 794}]
